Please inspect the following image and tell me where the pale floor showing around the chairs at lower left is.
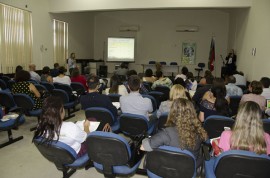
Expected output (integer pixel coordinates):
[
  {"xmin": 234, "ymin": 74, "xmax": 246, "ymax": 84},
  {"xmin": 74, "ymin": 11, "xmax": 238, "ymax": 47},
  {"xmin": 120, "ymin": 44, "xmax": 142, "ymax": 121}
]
[{"xmin": 0, "ymin": 111, "xmax": 146, "ymax": 178}]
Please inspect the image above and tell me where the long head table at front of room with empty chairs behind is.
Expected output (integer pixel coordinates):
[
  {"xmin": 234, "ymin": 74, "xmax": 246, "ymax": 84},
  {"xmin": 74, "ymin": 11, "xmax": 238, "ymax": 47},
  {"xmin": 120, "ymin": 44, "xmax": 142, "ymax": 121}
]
[{"xmin": 142, "ymin": 64, "xmax": 180, "ymax": 76}]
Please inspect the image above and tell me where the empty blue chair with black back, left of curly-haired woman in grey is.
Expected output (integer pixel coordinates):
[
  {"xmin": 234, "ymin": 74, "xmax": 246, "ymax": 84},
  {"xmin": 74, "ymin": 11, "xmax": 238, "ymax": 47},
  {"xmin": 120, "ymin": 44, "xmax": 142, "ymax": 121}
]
[{"xmin": 86, "ymin": 131, "xmax": 146, "ymax": 177}]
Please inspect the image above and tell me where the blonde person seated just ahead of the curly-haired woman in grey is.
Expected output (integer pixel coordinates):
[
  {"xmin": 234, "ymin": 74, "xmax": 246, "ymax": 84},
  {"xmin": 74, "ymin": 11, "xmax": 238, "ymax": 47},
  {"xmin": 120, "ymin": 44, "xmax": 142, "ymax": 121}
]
[{"xmin": 157, "ymin": 84, "xmax": 187, "ymax": 118}]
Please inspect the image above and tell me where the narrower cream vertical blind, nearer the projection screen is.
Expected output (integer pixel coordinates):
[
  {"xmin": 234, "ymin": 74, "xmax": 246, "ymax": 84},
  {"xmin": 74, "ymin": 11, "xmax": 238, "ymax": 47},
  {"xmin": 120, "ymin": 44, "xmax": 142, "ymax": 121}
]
[{"xmin": 53, "ymin": 19, "xmax": 68, "ymax": 66}]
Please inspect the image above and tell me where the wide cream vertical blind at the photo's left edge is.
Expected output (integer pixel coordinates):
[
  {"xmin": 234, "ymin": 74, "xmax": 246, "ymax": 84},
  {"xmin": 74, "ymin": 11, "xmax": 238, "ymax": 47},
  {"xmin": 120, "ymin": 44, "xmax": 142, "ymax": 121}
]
[{"xmin": 0, "ymin": 3, "xmax": 33, "ymax": 73}]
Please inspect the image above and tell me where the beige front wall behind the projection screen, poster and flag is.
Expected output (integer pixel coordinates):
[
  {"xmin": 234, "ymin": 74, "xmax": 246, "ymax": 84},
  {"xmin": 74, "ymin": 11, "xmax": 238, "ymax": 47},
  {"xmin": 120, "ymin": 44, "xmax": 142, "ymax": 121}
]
[{"xmin": 94, "ymin": 10, "xmax": 229, "ymax": 76}]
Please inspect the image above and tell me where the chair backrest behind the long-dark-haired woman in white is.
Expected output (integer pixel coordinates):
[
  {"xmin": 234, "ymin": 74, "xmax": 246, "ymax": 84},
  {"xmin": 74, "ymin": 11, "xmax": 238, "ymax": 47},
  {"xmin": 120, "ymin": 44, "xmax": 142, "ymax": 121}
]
[{"xmin": 34, "ymin": 138, "xmax": 77, "ymax": 170}]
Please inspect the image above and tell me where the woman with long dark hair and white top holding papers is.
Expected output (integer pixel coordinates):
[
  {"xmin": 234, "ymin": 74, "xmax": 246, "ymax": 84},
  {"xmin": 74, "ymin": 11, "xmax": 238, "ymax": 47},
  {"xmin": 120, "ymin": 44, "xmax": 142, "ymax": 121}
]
[{"xmin": 33, "ymin": 96, "xmax": 90, "ymax": 156}]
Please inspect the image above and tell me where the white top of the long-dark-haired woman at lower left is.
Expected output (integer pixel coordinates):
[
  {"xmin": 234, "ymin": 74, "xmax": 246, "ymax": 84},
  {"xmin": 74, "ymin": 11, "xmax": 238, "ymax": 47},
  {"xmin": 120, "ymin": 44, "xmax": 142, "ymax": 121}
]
[{"xmin": 59, "ymin": 122, "xmax": 87, "ymax": 153}]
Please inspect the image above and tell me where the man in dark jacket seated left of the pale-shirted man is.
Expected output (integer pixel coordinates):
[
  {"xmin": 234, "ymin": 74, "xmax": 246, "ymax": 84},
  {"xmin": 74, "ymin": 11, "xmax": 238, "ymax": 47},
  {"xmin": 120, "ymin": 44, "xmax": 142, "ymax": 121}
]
[{"xmin": 80, "ymin": 75, "xmax": 117, "ymax": 119}]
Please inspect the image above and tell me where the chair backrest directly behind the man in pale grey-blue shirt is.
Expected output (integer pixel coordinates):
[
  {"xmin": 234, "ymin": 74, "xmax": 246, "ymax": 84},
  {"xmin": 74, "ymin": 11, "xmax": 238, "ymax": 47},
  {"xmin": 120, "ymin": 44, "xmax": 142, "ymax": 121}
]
[{"xmin": 119, "ymin": 113, "xmax": 149, "ymax": 137}]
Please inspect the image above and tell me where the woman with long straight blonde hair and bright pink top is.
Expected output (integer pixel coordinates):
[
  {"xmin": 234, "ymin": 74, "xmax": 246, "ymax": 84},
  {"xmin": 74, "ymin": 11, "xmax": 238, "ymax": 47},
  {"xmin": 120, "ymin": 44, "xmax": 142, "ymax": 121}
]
[{"xmin": 219, "ymin": 101, "xmax": 270, "ymax": 155}]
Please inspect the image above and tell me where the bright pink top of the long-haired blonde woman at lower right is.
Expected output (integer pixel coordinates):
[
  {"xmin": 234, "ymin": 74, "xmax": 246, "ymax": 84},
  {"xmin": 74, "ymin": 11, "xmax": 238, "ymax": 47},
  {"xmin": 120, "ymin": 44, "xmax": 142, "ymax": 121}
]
[{"xmin": 218, "ymin": 131, "xmax": 270, "ymax": 155}]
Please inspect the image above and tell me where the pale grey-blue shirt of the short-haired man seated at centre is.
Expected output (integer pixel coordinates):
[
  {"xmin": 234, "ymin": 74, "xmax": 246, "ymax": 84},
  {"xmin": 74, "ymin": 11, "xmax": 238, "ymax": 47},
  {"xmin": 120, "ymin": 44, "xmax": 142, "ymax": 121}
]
[{"xmin": 120, "ymin": 92, "xmax": 153, "ymax": 120}]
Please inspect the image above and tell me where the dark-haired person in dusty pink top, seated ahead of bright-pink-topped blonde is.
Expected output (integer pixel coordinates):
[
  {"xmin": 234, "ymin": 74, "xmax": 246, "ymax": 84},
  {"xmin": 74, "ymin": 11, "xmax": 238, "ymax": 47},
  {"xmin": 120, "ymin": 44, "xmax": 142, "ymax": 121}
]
[{"xmin": 240, "ymin": 80, "xmax": 266, "ymax": 111}]
